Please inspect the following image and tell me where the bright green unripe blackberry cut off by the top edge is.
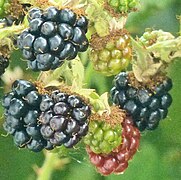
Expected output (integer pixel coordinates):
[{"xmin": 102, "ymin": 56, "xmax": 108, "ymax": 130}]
[{"xmin": 106, "ymin": 0, "xmax": 139, "ymax": 14}]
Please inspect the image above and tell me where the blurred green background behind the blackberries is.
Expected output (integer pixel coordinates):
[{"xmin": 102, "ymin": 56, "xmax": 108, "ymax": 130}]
[{"xmin": 0, "ymin": 0, "xmax": 181, "ymax": 180}]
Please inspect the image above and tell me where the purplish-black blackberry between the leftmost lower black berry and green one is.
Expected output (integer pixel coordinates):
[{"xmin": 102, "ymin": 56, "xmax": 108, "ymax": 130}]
[{"xmin": 40, "ymin": 90, "xmax": 91, "ymax": 148}]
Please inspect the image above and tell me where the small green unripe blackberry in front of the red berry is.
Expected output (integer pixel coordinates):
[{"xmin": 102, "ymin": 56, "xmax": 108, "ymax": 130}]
[{"xmin": 84, "ymin": 107, "xmax": 125, "ymax": 154}]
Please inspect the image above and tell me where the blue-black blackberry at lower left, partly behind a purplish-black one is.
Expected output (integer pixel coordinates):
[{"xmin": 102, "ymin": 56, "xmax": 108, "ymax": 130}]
[{"xmin": 2, "ymin": 80, "xmax": 49, "ymax": 152}]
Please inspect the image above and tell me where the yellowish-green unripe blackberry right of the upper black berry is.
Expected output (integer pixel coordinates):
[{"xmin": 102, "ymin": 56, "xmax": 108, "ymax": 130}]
[{"xmin": 89, "ymin": 30, "xmax": 132, "ymax": 76}]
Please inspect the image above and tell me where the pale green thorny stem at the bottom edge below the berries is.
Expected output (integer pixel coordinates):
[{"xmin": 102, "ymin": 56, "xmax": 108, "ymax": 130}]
[{"xmin": 37, "ymin": 152, "xmax": 69, "ymax": 180}]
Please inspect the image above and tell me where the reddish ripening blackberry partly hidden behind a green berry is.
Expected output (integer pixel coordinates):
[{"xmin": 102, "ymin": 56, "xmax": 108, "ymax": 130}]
[{"xmin": 87, "ymin": 117, "xmax": 140, "ymax": 176}]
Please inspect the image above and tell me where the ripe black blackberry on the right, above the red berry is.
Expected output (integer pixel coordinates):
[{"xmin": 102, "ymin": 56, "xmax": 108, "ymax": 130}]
[{"xmin": 111, "ymin": 72, "xmax": 172, "ymax": 131}]
